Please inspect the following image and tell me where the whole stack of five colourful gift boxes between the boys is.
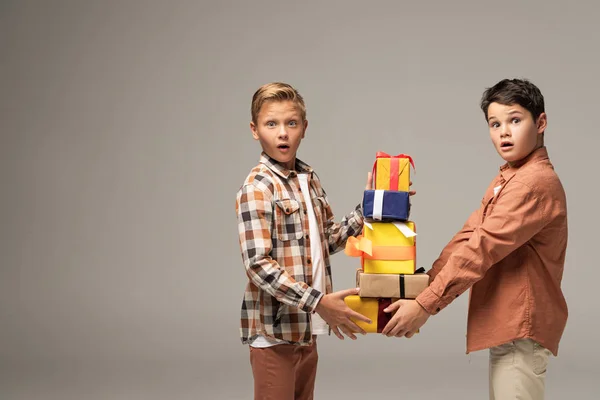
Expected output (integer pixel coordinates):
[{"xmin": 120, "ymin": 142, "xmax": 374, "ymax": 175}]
[{"xmin": 345, "ymin": 152, "xmax": 429, "ymax": 333}]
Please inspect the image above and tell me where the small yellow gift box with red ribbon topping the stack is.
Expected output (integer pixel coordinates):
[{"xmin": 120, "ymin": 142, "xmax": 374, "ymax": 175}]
[{"xmin": 373, "ymin": 151, "xmax": 415, "ymax": 192}]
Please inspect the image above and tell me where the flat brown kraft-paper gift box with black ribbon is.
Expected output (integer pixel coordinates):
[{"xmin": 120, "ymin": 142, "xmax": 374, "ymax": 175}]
[{"xmin": 356, "ymin": 268, "xmax": 429, "ymax": 299}]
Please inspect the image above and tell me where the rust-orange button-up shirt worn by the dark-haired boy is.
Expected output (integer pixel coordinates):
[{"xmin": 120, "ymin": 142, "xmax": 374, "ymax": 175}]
[{"xmin": 417, "ymin": 147, "xmax": 568, "ymax": 355}]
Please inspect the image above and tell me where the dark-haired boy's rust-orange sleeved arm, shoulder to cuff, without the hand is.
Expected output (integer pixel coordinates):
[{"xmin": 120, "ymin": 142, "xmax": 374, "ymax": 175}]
[{"xmin": 416, "ymin": 182, "xmax": 547, "ymax": 314}]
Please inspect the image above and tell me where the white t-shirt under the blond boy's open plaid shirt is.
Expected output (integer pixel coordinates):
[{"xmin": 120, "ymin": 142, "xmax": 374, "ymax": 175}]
[{"xmin": 250, "ymin": 173, "xmax": 329, "ymax": 347}]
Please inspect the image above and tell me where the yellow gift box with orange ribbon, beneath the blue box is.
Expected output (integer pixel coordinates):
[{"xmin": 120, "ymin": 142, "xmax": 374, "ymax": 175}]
[{"xmin": 362, "ymin": 221, "xmax": 417, "ymax": 274}]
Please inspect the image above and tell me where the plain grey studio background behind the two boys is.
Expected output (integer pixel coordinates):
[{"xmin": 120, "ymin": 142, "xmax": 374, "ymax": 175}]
[{"xmin": 0, "ymin": 0, "xmax": 600, "ymax": 400}]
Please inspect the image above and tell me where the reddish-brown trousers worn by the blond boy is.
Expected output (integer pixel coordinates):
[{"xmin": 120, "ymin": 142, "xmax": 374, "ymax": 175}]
[{"xmin": 250, "ymin": 337, "xmax": 319, "ymax": 400}]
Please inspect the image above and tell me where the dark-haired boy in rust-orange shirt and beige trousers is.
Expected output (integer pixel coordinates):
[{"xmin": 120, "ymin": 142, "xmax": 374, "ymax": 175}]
[{"xmin": 383, "ymin": 79, "xmax": 568, "ymax": 400}]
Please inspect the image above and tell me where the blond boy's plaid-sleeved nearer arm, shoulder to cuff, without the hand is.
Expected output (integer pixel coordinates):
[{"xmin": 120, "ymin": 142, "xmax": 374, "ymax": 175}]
[{"xmin": 236, "ymin": 184, "xmax": 323, "ymax": 312}]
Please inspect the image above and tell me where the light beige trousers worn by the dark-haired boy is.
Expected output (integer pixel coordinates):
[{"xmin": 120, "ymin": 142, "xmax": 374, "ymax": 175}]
[{"xmin": 490, "ymin": 339, "xmax": 551, "ymax": 400}]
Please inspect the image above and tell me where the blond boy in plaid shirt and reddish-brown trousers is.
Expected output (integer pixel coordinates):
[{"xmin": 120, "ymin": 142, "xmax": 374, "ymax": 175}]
[{"xmin": 236, "ymin": 82, "xmax": 371, "ymax": 400}]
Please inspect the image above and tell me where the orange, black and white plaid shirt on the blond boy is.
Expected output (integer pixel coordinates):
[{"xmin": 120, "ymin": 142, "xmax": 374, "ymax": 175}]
[{"xmin": 236, "ymin": 152, "xmax": 363, "ymax": 345}]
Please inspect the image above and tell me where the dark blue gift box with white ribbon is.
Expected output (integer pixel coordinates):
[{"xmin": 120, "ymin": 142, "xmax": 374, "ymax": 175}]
[{"xmin": 363, "ymin": 190, "xmax": 410, "ymax": 222}]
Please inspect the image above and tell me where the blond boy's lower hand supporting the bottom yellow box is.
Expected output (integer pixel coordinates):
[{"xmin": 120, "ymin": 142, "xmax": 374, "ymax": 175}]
[{"xmin": 315, "ymin": 288, "xmax": 371, "ymax": 340}]
